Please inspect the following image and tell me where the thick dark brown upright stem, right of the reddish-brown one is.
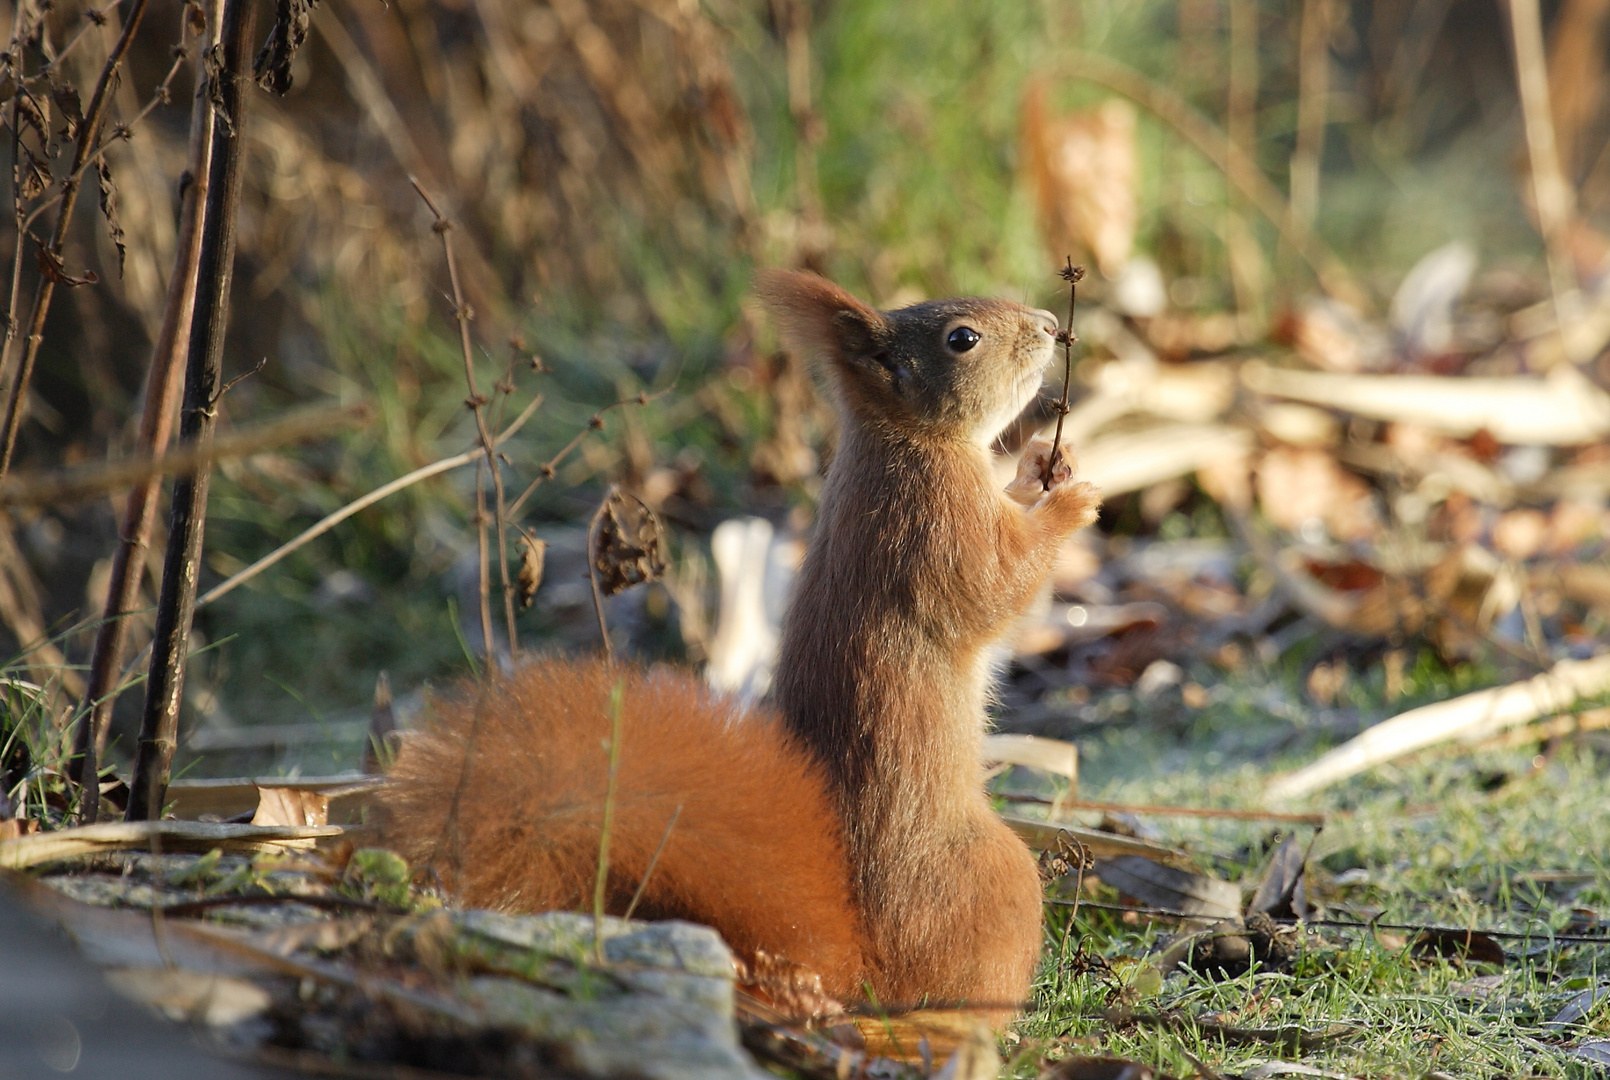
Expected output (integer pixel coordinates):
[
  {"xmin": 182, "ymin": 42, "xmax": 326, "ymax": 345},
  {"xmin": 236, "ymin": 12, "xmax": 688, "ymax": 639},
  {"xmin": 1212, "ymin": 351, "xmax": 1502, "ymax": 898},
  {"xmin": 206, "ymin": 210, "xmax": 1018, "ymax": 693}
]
[{"xmin": 127, "ymin": 0, "xmax": 254, "ymax": 821}]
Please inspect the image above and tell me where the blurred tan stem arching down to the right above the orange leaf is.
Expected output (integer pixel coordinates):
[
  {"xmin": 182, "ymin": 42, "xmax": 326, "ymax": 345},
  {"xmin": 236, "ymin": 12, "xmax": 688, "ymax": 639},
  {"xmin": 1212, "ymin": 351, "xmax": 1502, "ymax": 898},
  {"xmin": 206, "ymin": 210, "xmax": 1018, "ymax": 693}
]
[{"xmin": 1067, "ymin": 52, "xmax": 1370, "ymax": 311}]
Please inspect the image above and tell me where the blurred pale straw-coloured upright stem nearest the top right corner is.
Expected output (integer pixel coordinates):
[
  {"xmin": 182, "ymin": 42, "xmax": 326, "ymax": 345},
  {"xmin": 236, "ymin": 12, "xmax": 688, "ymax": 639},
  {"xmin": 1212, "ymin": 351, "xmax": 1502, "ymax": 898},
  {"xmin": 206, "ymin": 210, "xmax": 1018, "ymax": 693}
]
[{"xmin": 1505, "ymin": 0, "xmax": 1592, "ymax": 362}]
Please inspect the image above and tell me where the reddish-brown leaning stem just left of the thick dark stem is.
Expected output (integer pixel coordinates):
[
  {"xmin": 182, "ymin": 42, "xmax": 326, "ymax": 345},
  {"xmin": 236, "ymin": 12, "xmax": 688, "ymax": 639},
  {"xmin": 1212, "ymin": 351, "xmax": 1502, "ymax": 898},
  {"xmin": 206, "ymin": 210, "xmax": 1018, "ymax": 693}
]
[{"xmin": 68, "ymin": 0, "xmax": 219, "ymax": 824}]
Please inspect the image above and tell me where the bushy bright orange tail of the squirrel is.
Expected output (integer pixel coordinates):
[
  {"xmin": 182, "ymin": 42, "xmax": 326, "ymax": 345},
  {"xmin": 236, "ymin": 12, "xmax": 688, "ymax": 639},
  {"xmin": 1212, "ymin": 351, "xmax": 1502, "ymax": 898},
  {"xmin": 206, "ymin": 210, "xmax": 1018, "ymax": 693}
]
[{"xmin": 378, "ymin": 660, "xmax": 865, "ymax": 998}]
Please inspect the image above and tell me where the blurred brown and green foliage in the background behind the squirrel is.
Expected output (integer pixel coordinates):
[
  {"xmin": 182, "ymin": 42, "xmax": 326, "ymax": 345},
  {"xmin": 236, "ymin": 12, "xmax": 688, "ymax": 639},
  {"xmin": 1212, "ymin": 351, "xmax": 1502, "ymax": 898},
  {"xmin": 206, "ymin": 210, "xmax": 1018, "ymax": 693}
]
[{"xmin": 0, "ymin": 0, "xmax": 1610, "ymax": 771}]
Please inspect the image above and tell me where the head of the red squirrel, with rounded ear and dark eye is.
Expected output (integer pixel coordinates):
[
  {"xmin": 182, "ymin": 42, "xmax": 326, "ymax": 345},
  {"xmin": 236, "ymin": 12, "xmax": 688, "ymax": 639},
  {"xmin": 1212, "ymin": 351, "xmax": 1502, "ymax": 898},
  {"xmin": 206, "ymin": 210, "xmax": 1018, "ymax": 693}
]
[{"xmin": 755, "ymin": 270, "xmax": 1056, "ymax": 444}]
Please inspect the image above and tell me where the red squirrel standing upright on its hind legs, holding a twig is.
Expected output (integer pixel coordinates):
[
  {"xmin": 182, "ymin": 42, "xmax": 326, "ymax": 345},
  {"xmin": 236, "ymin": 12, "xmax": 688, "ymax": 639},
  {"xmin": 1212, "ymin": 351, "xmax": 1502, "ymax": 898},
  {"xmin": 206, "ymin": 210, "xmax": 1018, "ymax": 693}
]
[{"xmin": 380, "ymin": 272, "xmax": 1098, "ymax": 1016}]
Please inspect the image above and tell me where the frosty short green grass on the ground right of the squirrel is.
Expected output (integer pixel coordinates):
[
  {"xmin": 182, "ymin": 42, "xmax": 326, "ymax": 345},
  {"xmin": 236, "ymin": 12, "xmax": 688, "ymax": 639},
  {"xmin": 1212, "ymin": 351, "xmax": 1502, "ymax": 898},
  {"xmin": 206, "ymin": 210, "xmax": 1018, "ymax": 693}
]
[{"xmin": 1009, "ymin": 660, "xmax": 1610, "ymax": 1078}]
